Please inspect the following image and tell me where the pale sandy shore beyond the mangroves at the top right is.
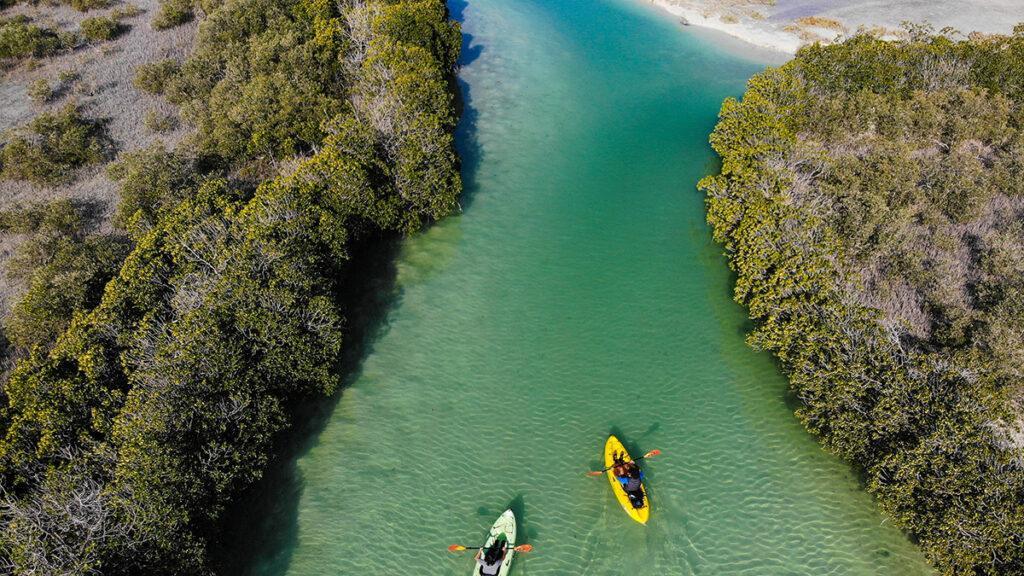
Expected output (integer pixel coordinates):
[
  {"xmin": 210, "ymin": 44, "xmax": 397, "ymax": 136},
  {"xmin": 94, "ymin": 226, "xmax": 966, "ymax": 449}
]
[{"xmin": 639, "ymin": 0, "xmax": 1024, "ymax": 54}]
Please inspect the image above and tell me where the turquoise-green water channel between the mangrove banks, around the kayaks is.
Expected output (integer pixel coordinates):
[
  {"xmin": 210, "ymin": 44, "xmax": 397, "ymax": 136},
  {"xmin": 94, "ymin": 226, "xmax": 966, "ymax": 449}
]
[{"xmin": 237, "ymin": 0, "xmax": 928, "ymax": 576}]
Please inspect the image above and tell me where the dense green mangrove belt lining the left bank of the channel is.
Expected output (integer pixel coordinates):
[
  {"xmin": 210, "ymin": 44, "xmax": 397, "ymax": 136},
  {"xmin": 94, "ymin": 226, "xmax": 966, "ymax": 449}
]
[{"xmin": 0, "ymin": 0, "xmax": 461, "ymax": 574}]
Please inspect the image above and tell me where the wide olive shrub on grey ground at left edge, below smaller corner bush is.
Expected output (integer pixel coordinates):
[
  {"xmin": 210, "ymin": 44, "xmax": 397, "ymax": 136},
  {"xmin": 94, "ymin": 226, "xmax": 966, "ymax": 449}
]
[{"xmin": 0, "ymin": 106, "xmax": 108, "ymax": 186}]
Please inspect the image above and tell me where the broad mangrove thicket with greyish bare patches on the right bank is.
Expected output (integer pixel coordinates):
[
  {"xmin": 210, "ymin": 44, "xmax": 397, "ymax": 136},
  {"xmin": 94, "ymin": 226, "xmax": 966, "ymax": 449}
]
[{"xmin": 700, "ymin": 27, "xmax": 1024, "ymax": 575}]
